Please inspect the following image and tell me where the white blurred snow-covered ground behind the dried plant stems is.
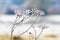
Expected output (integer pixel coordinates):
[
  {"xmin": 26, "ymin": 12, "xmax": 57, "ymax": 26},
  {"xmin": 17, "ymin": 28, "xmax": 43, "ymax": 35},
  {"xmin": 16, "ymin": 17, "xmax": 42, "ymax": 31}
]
[{"xmin": 0, "ymin": 15, "xmax": 60, "ymax": 34}]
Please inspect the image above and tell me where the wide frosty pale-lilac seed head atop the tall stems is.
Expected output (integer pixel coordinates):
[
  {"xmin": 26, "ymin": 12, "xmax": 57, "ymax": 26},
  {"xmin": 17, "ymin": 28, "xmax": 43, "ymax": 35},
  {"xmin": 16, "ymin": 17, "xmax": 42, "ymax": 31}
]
[{"xmin": 14, "ymin": 8, "xmax": 45, "ymax": 16}]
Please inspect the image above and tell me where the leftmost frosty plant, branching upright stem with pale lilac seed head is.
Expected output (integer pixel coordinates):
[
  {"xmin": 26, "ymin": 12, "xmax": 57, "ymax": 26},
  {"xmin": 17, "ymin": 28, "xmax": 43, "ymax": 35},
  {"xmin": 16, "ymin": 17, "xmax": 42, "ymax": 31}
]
[{"xmin": 11, "ymin": 9, "xmax": 29, "ymax": 40}]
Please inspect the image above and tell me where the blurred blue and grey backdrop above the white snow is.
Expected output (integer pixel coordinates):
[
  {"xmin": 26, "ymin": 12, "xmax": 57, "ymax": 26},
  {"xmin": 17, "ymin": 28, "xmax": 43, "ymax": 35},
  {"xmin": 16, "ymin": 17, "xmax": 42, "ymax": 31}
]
[{"xmin": 0, "ymin": 0, "xmax": 60, "ymax": 15}]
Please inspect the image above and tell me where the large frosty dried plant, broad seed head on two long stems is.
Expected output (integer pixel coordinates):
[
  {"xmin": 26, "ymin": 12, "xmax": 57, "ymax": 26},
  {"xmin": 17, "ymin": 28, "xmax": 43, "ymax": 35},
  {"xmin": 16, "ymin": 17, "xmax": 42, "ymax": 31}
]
[{"xmin": 11, "ymin": 8, "xmax": 43, "ymax": 40}]
